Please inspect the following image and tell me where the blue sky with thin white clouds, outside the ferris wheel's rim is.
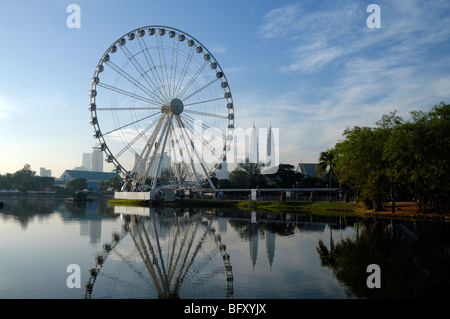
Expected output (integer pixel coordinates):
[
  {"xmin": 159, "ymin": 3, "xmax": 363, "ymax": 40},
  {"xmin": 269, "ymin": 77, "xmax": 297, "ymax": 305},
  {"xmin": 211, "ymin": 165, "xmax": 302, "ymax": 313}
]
[{"xmin": 0, "ymin": 0, "xmax": 450, "ymax": 177}]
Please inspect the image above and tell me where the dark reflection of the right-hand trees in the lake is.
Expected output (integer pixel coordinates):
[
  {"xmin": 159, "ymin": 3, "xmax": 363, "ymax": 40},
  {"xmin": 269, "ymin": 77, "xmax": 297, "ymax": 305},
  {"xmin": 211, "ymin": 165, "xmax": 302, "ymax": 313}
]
[{"xmin": 317, "ymin": 218, "xmax": 450, "ymax": 298}]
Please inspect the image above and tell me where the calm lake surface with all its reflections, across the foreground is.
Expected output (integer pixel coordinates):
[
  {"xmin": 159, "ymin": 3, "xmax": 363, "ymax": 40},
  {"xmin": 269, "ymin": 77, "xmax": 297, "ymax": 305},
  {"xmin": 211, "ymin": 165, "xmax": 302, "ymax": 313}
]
[{"xmin": 0, "ymin": 199, "xmax": 450, "ymax": 299}]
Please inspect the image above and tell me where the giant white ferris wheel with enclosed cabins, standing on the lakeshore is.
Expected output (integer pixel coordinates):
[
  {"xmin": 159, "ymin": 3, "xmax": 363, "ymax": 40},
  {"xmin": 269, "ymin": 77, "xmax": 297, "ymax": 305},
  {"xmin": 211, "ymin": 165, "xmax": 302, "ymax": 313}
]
[{"xmin": 89, "ymin": 26, "xmax": 235, "ymax": 191}]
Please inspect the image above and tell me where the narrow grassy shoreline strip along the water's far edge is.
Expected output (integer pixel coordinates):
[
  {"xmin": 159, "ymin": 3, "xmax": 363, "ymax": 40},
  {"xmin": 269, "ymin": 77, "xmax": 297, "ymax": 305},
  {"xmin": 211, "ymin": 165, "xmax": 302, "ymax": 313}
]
[{"xmin": 108, "ymin": 199, "xmax": 450, "ymax": 222}]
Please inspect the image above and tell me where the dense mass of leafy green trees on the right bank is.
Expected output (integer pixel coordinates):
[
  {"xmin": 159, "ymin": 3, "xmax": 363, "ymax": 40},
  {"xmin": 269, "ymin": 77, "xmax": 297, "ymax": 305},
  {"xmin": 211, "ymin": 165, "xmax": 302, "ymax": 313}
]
[{"xmin": 320, "ymin": 102, "xmax": 450, "ymax": 212}]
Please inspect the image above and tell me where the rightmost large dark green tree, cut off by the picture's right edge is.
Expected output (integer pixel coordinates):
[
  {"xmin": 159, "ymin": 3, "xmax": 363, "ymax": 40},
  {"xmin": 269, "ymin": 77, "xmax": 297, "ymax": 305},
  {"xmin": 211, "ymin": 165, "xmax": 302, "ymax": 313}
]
[{"xmin": 383, "ymin": 103, "xmax": 450, "ymax": 212}]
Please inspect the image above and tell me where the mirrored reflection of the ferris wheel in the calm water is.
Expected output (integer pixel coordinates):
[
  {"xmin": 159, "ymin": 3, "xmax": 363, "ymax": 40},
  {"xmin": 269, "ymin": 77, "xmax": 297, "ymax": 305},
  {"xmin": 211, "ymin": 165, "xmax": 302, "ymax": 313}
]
[{"xmin": 85, "ymin": 208, "xmax": 234, "ymax": 299}]
